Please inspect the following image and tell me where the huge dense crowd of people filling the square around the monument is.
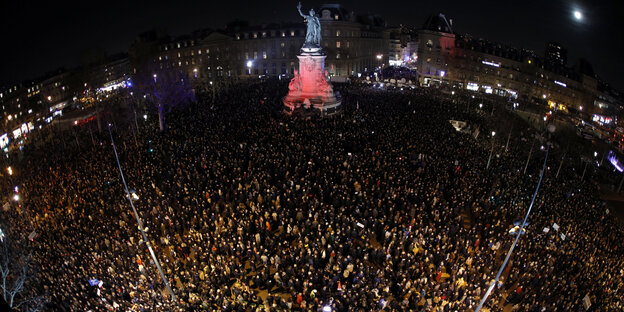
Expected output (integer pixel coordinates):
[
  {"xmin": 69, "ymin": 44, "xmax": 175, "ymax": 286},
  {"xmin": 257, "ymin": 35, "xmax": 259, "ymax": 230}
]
[{"xmin": 0, "ymin": 80, "xmax": 624, "ymax": 312}]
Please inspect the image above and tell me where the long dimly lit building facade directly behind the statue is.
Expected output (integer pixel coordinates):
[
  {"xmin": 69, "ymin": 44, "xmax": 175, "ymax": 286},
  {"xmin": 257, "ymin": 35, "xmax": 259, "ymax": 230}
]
[{"xmin": 130, "ymin": 5, "xmax": 390, "ymax": 87}]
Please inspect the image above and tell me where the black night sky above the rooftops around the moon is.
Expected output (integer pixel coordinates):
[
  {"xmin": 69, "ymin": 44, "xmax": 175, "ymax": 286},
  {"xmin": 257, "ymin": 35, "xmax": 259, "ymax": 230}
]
[{"xmin": 0, "ymin": 0, "xmax": 624, "ymax": 90}]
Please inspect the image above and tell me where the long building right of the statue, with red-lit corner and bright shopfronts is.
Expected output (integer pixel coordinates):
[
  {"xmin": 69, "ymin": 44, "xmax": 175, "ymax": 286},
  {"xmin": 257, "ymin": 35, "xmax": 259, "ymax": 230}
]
[{"xmin": 417, "ymin": 14, "xmax": 598, "ymax": 112}]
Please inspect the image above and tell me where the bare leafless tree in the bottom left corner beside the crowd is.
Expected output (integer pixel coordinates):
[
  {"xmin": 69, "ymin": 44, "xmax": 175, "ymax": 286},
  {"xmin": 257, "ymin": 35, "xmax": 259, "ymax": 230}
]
[{"xmin": 0, "ymin": 236, "xmax": 43, "ymax": 311}]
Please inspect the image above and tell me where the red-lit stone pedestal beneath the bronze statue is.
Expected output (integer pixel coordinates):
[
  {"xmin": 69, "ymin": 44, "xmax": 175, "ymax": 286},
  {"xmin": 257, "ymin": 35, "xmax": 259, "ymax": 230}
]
[{"xmin": 283, "ymin": 46, "xmax": 342, "ymax": 116}]
